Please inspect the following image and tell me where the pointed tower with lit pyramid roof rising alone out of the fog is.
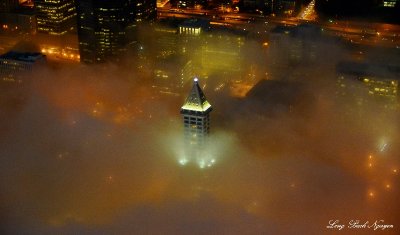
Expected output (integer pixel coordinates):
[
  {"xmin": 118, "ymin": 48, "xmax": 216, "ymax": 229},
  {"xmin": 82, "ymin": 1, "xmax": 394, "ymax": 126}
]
[{"xmin": 179, "ymin": 78, "xmax": 214, "ymax": 168}]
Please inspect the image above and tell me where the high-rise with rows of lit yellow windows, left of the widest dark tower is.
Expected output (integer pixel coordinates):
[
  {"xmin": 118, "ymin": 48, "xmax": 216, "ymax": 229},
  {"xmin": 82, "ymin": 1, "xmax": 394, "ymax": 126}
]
[{"xmin": 34, "ymin": 0, "xmax": 79, "ymax": 35}]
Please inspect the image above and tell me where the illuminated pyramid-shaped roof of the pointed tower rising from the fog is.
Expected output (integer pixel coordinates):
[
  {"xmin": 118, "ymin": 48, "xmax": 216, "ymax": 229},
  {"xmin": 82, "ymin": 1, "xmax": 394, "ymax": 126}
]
[{"xmin": 182, "ymin": 77, "xmax": 212, "ymax": 112}]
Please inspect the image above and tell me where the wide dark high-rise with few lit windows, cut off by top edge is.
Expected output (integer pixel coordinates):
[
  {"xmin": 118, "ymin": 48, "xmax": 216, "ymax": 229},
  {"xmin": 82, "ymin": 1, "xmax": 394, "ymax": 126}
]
[{"xmin": 77, "ymin": 0, "xmax": 156, "ymax": 63}]
